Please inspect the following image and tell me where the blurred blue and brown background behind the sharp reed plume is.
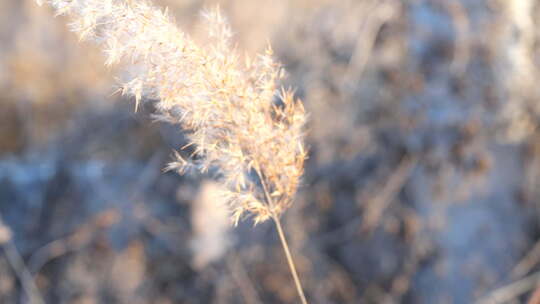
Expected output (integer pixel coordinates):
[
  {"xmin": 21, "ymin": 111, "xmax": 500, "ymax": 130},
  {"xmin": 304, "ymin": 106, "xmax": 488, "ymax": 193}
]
[{"xmin": 0, "ymin": 0, "xmax": 540, "ymax": 304}]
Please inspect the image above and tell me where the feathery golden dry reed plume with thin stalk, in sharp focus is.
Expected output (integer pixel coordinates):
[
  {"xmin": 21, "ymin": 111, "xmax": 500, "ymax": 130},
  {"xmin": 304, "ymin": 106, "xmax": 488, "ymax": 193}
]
[{"xmin": 37, "ymin": 0, "xmax": 307, "ymax": 303}]
